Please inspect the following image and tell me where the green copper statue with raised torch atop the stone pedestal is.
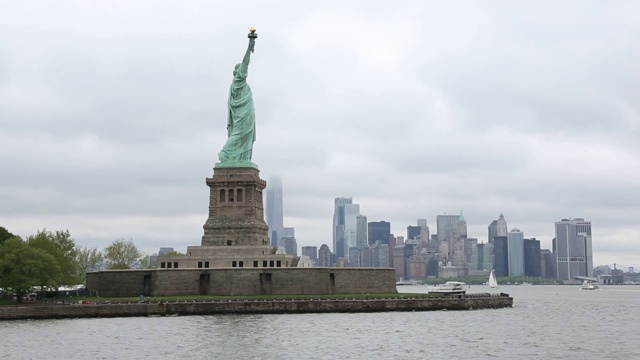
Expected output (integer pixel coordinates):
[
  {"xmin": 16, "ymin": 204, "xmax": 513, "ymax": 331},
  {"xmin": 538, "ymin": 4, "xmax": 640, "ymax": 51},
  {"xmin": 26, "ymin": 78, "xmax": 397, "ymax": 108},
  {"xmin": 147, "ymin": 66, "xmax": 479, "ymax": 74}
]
[{"xmin": 216, "ymin": 27, "xmax": 258, "ymax": 168}]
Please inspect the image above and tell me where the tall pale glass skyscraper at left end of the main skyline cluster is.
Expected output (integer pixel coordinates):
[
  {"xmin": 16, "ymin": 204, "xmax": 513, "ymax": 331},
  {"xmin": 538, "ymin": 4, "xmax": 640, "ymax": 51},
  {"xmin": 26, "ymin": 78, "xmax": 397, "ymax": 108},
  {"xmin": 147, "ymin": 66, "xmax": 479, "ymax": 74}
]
[{"xmin": 333, "ymin": 197, "xmax": 360, "ymax": 258}]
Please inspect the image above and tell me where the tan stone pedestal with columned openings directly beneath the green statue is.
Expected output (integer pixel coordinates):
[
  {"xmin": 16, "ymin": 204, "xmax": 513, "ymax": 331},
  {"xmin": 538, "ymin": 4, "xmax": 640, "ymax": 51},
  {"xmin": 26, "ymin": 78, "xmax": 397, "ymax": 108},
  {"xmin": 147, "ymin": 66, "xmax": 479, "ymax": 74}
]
[{"xmin": 202, "ymin": 167, "xmax": 270, "ymax": 249}]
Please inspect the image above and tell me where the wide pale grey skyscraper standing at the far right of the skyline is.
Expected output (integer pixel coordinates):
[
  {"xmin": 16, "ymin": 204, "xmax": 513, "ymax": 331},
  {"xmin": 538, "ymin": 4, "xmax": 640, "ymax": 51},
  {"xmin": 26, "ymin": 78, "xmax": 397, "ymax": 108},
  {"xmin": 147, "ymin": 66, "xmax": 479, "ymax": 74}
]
[{"xmin": 555, "ymin": 218, "xmax": 593, "ymax": 280}]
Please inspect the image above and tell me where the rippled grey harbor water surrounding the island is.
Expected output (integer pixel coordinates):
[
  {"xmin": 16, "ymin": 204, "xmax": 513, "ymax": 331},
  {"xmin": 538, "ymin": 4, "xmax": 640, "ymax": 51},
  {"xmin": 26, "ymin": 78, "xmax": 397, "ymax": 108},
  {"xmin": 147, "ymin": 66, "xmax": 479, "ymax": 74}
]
[{"xmin": 0, "ymin": 285, "xmax": 640, "ymax": 359}]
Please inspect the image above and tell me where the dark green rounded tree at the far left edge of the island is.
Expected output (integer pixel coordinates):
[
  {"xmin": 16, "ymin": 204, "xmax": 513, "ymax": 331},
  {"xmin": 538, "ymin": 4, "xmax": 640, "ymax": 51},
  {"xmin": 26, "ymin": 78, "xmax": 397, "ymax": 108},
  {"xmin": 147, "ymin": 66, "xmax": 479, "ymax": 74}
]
[{"xmin": 0, "ymin": 237, "xmax": 60, "ymax": 302}]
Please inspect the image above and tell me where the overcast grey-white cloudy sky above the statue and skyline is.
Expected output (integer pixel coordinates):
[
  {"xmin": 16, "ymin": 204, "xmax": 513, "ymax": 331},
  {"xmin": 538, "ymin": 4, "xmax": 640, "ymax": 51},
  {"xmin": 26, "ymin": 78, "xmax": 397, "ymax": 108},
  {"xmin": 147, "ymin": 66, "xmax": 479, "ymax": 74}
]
[{"xmin": 0, "ymin": 0, "xmax": 640, "ymax": 268}]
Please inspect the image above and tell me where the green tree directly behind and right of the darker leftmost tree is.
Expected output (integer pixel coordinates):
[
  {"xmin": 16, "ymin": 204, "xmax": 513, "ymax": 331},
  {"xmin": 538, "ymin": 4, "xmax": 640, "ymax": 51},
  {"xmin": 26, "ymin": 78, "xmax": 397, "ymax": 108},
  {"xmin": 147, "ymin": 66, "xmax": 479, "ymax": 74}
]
[{"xmin": 27, "ymin": 229, "xmax": 82, "ymax": 290}]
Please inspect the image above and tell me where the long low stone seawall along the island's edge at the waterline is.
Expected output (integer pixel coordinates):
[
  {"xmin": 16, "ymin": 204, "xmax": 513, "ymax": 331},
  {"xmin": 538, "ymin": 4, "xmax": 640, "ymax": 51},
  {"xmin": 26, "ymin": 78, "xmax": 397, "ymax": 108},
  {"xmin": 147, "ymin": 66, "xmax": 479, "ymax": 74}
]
[{"xmin": 0, "ymin": 294, "xmax": 513, "ymax": 320}]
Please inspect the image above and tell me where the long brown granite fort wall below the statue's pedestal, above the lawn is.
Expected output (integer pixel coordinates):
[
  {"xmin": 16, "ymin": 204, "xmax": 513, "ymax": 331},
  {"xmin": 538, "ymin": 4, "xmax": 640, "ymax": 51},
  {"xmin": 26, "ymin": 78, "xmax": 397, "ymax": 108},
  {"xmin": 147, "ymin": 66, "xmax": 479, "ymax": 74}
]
[{"xmin": 87, "ymin": 267, "xmax": 397, "ymax": 297}]
